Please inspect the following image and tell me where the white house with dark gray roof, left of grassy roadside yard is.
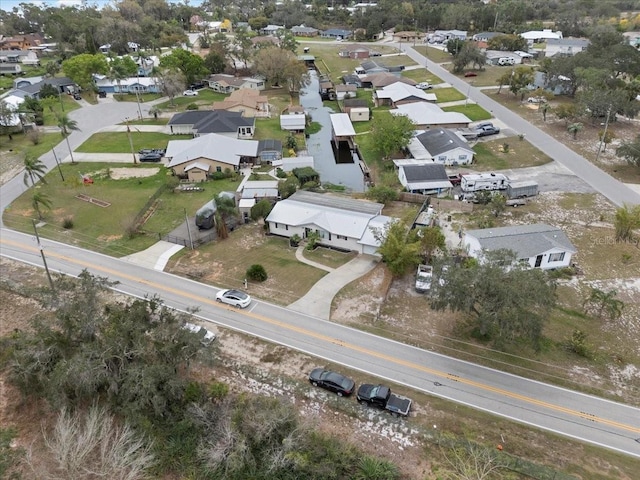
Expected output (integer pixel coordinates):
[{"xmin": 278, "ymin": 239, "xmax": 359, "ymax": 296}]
[{"xmin": 407, "ymin": 128, "xmax": 475, "ymax": 165}]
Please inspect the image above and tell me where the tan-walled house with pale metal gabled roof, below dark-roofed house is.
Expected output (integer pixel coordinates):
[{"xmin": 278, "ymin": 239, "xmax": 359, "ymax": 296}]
[{"xmin": 165, "ymin": 133, "xmax": 258, "ymax": 177}]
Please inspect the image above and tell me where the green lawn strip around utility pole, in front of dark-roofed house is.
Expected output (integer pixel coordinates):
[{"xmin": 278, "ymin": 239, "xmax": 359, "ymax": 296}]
[{"xmin": 76, "ymin": 132, "xmax": 193, "ymax": 153}]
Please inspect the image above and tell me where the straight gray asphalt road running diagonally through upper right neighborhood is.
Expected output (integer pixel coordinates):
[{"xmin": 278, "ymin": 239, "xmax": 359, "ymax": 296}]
[{"xmin": 400, "ymin": 43, "xmax": 640, "ymax": 206}]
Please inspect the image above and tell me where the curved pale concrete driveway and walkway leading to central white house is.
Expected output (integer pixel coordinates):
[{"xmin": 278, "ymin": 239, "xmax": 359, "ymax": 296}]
[{"xmin": 287, "ymin": 253, "xmax": 380, "ymax": 320}]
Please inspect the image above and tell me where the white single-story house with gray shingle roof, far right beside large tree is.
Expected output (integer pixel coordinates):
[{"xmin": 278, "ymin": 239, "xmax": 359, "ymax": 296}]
[{"xmin": 462, "ymin": 223, "xmax": 577, "ymax": 270}]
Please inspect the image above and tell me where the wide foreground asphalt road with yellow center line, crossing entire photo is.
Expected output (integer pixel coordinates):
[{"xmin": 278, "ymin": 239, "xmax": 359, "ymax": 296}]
[{"xmin": 0, "ymin": 229, "xmax": 640, "ymax": 458}]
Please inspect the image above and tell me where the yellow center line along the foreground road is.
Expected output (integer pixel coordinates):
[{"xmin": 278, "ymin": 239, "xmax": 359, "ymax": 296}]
[{"xmin": 0, "ymin": 239, "xmax": 640, "ymax": 434}]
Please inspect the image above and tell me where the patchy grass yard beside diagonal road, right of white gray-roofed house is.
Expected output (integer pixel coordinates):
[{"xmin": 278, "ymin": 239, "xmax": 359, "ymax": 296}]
[{"xmin": 473, "ymin": 137, "xmax": 553, "ymax": 171}]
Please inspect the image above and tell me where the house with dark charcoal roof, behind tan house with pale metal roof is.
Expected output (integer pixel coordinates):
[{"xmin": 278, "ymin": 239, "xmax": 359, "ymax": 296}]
[{"xmin": 167, "ymin": 110, "xmax": 256, "ymax": 138}]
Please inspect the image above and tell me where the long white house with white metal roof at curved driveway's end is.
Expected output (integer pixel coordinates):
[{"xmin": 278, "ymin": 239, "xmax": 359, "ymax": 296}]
[{"xmin": 266, "ymin": 190, "xmax": 394, "ymax": 255}]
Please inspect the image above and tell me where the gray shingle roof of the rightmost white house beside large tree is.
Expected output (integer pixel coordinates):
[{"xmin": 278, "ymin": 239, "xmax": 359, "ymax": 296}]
[{"xmin": 466, "ymin": 223, "xmax": 577, "ymax": 258}]
